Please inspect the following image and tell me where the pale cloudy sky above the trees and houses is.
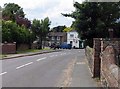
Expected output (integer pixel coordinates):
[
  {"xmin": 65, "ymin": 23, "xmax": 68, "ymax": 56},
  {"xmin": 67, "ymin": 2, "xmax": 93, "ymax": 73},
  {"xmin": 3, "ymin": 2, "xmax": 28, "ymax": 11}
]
[{"xmin": 0, "ymin": 0, "xmax": 84, "ymax": 28}]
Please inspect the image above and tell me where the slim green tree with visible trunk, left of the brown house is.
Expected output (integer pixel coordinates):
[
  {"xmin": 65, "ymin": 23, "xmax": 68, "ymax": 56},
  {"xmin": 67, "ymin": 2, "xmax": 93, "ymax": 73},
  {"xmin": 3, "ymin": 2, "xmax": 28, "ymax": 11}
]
[{"xmin": 31, "ymin": 17, "xmax": 51, "ymax": 49}]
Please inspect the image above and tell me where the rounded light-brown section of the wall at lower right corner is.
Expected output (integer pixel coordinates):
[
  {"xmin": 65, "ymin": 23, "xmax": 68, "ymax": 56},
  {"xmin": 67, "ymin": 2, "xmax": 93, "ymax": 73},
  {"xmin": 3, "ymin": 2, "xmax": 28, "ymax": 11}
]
[{"xmin": 101, "ymin": 46, "xmax": 118, "ymax": 87}]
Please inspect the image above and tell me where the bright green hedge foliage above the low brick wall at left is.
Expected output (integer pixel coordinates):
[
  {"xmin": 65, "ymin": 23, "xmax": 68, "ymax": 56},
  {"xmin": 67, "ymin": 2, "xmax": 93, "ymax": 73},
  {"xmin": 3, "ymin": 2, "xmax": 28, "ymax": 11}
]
[{"xmin": 2, "ymin": 21, "xmax": 35, "ymax": 44}]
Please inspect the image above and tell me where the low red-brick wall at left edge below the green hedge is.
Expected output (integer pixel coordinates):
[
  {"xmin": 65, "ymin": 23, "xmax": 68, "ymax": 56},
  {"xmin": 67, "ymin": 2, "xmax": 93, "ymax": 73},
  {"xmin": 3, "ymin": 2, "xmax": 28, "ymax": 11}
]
[{"xmin": 0, "ymin": 43, "xmax": 16, "ymax": 54}]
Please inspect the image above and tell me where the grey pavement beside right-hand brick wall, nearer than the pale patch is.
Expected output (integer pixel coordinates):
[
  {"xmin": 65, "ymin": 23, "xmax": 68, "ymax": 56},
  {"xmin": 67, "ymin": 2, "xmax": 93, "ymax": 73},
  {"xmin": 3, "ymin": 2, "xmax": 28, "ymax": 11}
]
[{"xmin": 70, "ymin": 59, "xmax": 98, "ymax": 88}]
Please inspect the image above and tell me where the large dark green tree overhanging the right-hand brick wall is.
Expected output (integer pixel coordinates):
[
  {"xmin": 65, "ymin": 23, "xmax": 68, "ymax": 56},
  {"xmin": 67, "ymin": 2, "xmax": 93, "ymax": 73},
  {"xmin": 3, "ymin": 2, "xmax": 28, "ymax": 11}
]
[{"xmin": 63, "ymin": 2, "xmax": 120, "ymax": 46}]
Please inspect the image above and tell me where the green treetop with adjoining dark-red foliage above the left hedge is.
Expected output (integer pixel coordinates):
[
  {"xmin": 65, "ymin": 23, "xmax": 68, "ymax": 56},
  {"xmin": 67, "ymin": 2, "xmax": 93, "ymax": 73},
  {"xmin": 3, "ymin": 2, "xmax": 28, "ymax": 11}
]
[{"xmin": 2, "ymin": 3, "xmax": 31, "ymax": 28}]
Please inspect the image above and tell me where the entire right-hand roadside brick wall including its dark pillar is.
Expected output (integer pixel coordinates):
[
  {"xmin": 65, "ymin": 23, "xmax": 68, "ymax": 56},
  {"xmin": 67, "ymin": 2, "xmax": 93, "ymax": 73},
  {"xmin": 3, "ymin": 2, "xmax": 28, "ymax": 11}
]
[{"xmin": 86, "ymin": 38, "xmax": 120, "ymax": 88}]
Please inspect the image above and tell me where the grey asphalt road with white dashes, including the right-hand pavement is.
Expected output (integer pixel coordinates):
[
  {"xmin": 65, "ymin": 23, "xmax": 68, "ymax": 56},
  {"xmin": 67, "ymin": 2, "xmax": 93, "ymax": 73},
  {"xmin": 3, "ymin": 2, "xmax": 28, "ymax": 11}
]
[{"xmin": 0, "ymin": 49, "xmax": 97, "ymax": 87}]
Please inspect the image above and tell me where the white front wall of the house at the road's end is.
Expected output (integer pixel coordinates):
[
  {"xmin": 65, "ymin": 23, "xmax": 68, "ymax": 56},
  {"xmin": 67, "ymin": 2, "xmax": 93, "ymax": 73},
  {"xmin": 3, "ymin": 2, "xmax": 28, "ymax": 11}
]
[{"xmin": 67, "ymin": 31, "xmax": 80, "ymax": 48}]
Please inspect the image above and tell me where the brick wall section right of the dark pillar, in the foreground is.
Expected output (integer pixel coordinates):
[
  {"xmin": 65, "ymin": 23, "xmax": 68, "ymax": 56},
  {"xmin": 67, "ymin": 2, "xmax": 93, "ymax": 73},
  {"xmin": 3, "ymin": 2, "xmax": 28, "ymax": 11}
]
[{"xmin": 101, "ymin": 38, "xmax": 120, "ymax": 89}]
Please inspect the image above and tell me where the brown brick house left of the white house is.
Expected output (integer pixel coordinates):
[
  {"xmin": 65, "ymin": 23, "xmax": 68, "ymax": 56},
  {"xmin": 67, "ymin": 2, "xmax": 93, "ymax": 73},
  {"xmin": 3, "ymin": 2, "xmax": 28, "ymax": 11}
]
[{"xmin": 48, "ymin": 32, "xmax": 67, "ymax": 46}]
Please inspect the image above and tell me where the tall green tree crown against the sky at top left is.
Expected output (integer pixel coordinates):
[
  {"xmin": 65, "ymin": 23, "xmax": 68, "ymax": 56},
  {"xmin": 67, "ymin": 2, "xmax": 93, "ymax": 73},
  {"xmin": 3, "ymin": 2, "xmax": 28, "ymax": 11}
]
[{"xmin": 2, "ymin": 3, "xmax": 25, "ymax": 22}]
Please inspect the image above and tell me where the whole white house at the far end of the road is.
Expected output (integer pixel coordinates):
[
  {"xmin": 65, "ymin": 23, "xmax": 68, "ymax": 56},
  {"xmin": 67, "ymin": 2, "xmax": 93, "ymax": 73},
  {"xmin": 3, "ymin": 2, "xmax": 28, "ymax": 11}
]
[{"xmin": 67, "ymin": 30, "xmax": 83, "ymax": 48}]
